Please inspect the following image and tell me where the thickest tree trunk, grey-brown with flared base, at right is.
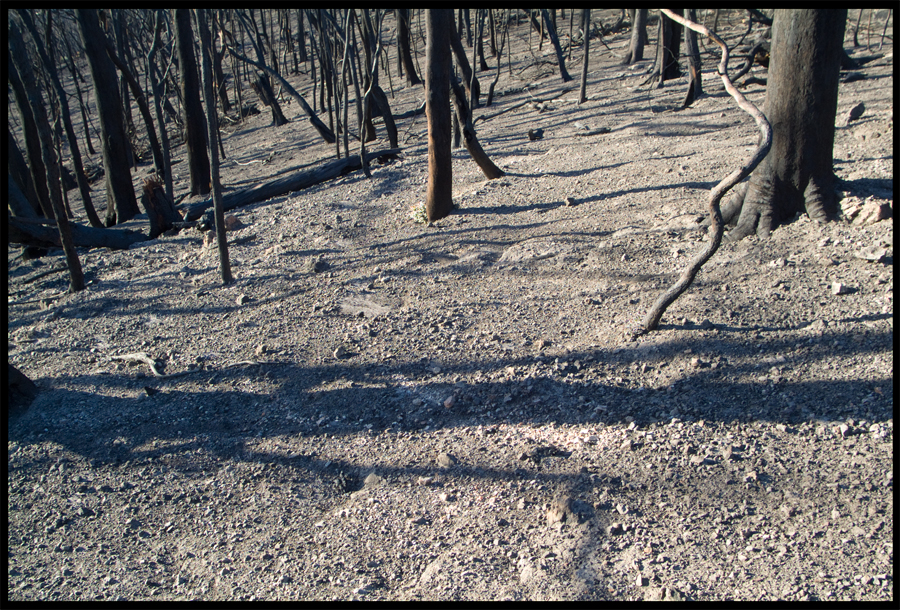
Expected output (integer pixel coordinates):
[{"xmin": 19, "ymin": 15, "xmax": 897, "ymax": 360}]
[{"xmin": 722, "ymin": 9, "xmax": 847, "ymax": 241}]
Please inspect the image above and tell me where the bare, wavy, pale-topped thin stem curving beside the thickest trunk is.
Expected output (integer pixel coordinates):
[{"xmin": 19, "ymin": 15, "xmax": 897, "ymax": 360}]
[{"xmin": 631, "ymin": 9, "xmax": 772, "ymax": 336}]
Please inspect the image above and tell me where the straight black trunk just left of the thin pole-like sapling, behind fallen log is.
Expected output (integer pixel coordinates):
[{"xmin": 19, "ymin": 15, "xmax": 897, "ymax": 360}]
[{"xmin": 173, "ymin": 8, "xmax": 211, "ymax": 195}]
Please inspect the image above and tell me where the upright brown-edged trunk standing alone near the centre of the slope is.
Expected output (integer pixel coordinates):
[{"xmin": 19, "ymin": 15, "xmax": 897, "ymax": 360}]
[{"xmin": 425, "ymin": 9, "xmax": 450, "ymax": 222}]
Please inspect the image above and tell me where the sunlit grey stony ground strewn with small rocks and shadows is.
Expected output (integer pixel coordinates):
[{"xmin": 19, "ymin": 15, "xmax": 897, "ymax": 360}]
[{"xmin": 7, "ymin": 11, "xmax": 894, "ymax": 601}]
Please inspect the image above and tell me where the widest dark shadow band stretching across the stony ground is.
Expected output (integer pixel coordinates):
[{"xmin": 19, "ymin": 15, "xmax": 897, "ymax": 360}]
[{"xmin": 9, "ymin": 324, "xmax": 893, "ymax": 467}]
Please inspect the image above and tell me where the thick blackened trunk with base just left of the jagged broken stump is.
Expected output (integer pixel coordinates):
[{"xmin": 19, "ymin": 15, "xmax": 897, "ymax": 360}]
[{"xmin": 75, "ymin": 9, "xmax": 138, "ymax": 227}]
